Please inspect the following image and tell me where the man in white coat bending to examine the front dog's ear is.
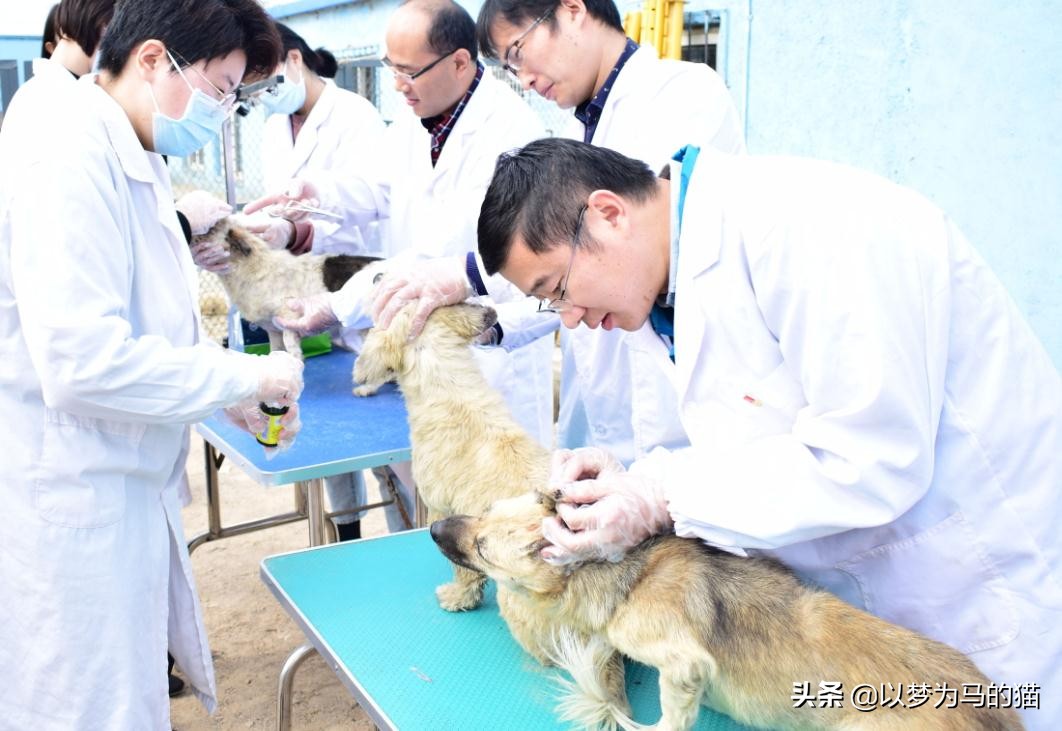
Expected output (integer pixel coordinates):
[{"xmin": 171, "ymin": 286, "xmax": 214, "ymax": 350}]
[{"xmin": 479, "ymin": 139, "xmax": 1062, "ymax": 729}]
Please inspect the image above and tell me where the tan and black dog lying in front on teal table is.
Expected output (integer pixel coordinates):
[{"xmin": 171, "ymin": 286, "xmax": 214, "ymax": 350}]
[{"xmin": 431, "ymin": 493, "xmax": 1022, "ymax": 731}]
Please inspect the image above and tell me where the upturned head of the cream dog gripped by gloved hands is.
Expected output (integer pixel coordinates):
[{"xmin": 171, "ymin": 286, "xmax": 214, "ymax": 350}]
[{"xmin": 354, "ymin": 304, "xmax": 498, "ymax": 384}]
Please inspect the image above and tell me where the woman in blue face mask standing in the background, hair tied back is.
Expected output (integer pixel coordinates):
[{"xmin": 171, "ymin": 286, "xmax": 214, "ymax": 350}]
[{"xmin": 241, "ymin": 23, "xmax": 384, "ymax": 254}]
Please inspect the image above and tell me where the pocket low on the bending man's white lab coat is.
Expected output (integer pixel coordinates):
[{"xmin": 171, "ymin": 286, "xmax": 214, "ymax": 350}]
[{"xmin": 837, "ymin": 512, "xmax": 1018, "ymax": 653}]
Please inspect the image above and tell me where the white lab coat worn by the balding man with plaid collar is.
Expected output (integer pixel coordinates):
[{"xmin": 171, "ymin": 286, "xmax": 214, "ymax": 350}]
[{"xmin": 323, "ymin": 71, "xmax": 555, "ymax": 446}]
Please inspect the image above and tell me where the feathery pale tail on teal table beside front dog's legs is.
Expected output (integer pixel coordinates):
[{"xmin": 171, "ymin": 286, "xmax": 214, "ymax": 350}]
[{"xmin": 549, "ymin": 630, "xmax": 651, "ymax": 731}]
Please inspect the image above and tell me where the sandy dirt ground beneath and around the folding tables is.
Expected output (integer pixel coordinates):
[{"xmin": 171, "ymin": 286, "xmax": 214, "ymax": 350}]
[{"xmin": 170, "ymin": 435, "xmax": 387, "ymax": 731}]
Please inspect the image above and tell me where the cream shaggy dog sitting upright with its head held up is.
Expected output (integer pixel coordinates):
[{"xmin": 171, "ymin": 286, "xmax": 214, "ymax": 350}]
[{"xmin": 354, "ymin": 304, "xmax": 549, "ymax": 611}]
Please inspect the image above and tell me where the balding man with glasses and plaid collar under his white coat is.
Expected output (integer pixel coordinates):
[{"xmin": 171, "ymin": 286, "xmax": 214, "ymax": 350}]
[{"xmin": 246, "ymin": 0, "xmax": 555, "ymax": 529}]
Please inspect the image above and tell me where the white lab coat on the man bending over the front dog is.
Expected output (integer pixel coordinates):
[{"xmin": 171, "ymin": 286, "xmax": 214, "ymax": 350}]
[{"xmin": 632, "ymin": 151, "xmax": 1062, "ymax": 729}]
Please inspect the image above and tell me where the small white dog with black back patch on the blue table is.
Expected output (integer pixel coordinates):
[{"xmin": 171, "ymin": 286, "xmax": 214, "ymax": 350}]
[{"xmin": 192, "ymin": 218, "xmax": 379, "ymax": 357}]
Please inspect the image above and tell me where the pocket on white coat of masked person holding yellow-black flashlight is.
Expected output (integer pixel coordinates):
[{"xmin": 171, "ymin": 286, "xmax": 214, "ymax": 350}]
[{"xmin": 35, "ymin": 411, "xmax": 145, "ymax": 528}]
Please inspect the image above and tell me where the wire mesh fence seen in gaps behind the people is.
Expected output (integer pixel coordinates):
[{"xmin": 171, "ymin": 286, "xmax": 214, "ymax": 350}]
[{"xmin": 170, "ymin": 52, "xmax": 570, "ymax": 342}]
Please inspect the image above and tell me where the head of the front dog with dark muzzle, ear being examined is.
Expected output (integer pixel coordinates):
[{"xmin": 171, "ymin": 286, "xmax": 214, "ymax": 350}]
[{"xmin": 431, "ymin": 492, "xmax": 568, "ymax": 594}]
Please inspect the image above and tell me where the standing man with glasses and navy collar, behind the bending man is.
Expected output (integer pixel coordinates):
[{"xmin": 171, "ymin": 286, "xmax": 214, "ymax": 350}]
[{"xmin": 374, "ymin": 0, "xmax": 744, "ymax": 463}]
